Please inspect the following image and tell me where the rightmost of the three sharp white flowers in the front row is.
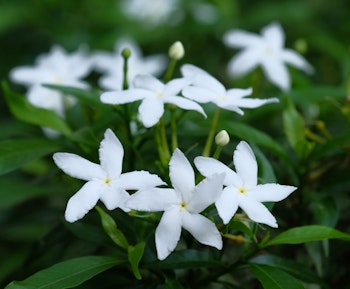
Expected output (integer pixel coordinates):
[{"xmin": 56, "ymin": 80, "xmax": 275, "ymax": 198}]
[{"xmin": 194, "ymin": 141, "xmax": 297, "ymax": 227}]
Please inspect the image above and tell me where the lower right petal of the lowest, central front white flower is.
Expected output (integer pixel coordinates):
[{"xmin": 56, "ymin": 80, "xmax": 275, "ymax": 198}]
[{"xmin": 182, "ymin": 211, "xmax": 222, "ymax": 250}]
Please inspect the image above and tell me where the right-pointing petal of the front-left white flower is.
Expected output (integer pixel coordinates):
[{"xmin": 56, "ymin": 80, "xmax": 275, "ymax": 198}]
[{"xmin": 118, "ymin": 171, "xmax": 165, "ymax": 190}]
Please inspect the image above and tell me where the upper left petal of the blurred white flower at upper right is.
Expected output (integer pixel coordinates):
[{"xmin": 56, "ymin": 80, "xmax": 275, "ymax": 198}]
[{"xmin": 223, "ymin": 29, "xmax": 261, "ymax": 48}]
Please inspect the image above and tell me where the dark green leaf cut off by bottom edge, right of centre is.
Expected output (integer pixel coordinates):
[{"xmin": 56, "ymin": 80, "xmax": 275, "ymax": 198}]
[{"xmin": 249, "ymin": 264, "xmax": 305, "ymax": 289}]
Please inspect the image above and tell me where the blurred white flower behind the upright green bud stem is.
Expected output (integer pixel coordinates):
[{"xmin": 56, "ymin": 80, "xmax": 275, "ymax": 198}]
[{"xmin": 93, "ymin": 39, "xmax": 167, "ymax": 90}]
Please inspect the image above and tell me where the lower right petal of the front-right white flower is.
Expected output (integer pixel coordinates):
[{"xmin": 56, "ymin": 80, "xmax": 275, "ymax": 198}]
[{"xmin": 239, "ymin": 195, "xmax": 278, "ymax": 228}]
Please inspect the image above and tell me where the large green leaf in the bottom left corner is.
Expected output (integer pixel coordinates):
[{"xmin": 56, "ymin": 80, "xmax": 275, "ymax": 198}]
[{"xmin": 5, "ymin": 256, "xmax": 125, "ymax": 289}]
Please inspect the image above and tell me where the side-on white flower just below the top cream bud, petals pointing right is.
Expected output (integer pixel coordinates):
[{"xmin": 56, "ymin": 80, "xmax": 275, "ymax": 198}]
[{"xmin": 181, "ymin": 64, "xmax": 278, "ymax": 115}]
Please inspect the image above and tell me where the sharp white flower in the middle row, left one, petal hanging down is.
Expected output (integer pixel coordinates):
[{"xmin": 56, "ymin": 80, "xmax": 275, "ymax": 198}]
[{"xmin": 101, "ymin": 75, "xmax": 206, "ymax": 127}]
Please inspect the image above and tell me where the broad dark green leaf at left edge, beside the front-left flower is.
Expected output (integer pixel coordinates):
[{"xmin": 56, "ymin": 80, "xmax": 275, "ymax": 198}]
[{"xmin": 0, "ymin": 139, "xmax": 60, "ymax": 174}]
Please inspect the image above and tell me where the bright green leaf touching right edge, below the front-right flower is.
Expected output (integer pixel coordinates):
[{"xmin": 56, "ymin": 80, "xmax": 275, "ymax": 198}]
[{"xmin": 264, "ymin": 225, "xmax": 350, "ymax": 247}]
